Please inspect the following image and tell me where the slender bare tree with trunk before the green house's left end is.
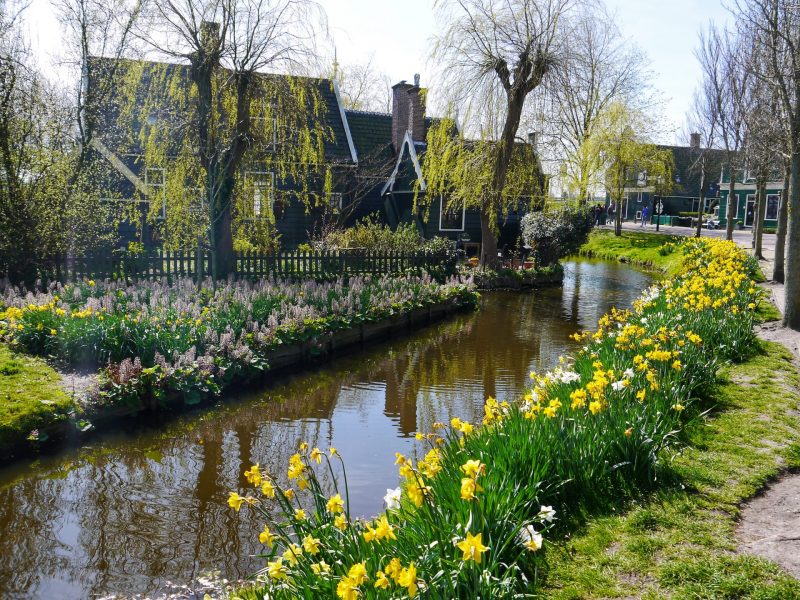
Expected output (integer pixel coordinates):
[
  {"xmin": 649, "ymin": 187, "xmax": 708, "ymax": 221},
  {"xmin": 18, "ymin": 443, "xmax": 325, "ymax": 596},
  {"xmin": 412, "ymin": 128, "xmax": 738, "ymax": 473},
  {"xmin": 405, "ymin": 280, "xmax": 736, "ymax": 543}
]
[{"xmin": 696, "ymin": 25, "xmax": 751, "ymax": 240}]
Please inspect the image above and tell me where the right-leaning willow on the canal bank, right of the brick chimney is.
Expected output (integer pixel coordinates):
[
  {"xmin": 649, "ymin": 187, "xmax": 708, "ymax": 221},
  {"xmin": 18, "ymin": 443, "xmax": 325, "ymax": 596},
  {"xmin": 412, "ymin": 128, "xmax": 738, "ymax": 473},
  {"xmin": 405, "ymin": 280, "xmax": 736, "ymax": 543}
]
[{"xmin": 424, "ymin": 0, "xmax": 578, "ymax": 266}]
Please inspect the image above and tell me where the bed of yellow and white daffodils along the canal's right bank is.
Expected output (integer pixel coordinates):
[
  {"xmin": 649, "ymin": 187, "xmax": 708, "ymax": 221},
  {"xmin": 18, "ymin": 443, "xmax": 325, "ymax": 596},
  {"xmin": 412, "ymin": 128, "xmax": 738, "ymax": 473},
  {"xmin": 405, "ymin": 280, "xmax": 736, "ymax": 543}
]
[{"xmin": 229, "ymin": 240, "xmax": 760, "ymax": 599}]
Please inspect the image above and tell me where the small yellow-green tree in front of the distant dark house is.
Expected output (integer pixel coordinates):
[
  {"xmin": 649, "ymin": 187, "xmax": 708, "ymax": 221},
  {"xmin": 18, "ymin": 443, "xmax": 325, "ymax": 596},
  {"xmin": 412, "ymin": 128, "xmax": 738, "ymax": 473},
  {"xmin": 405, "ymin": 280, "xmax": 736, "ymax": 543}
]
[{"xmin": 589, "ymin": 102, "xmax": 674, "ymax": 235}]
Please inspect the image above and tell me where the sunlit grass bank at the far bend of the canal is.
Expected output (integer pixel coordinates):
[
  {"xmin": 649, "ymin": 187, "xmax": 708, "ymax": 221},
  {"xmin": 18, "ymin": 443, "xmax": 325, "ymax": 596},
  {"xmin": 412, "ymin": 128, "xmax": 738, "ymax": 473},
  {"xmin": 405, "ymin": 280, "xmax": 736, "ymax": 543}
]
[{"xmin": 580, "ymin": 229, "xmax": 686, "ymax": 274}]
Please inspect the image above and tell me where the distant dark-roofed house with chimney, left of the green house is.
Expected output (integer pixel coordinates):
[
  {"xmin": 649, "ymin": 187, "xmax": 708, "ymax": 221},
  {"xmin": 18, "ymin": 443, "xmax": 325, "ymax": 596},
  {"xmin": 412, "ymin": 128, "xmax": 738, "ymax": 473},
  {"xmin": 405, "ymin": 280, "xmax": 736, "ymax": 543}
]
[{"xmin": 608, "ymin": 133, "xmax": 724, "ymax": 222}]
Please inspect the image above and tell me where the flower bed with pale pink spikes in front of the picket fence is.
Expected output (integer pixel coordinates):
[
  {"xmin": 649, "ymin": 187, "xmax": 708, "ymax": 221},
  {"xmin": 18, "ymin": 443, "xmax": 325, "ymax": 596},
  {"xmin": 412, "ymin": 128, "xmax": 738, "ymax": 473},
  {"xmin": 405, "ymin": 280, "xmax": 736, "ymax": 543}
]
[{"xmin": 0, "ymin": 276, "xmax": 476, "ymax": 403}]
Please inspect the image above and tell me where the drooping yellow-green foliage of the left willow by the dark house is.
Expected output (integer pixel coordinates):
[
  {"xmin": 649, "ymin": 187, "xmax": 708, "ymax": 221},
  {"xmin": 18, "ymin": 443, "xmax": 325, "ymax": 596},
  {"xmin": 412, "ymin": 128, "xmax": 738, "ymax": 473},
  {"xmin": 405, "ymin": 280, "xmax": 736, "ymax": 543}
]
[{"xmin": 108, "ymin": 61, "xmax": 333, "ymax": 250}]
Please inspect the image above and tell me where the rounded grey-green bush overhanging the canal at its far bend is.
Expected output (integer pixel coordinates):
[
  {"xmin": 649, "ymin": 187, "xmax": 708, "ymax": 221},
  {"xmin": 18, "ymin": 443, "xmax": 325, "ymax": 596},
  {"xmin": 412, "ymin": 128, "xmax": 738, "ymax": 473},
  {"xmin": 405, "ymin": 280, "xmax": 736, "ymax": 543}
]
[{"xmin": 522, "ymin": 207, "xmax": 592, "ymax": 267}]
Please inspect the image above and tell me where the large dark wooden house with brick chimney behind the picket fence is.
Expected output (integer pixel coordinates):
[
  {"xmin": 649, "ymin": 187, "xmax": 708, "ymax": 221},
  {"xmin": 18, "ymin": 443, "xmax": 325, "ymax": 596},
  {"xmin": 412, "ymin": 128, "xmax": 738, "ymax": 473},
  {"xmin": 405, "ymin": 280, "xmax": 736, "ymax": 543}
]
[{"xmin": 86, "ymin": 58, "xmax": 536, "ymax": 249}]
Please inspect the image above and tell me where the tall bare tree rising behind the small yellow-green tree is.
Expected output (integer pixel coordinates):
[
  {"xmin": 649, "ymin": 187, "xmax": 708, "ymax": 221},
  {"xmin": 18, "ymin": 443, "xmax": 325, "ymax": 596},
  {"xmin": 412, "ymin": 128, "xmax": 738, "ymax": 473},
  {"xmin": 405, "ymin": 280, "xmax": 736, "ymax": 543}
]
[{"xmin": 541, "ymin": 6, "xmax": 654, "ymax": 203}]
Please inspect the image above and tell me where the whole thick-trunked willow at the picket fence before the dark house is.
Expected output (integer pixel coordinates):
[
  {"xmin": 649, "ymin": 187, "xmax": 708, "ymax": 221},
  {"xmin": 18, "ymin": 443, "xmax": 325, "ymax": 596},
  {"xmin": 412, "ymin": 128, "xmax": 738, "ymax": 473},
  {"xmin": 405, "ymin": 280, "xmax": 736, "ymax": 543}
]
[{"xmin": 109, "ymin": 0, "xmax": 331, "ymax": 277}]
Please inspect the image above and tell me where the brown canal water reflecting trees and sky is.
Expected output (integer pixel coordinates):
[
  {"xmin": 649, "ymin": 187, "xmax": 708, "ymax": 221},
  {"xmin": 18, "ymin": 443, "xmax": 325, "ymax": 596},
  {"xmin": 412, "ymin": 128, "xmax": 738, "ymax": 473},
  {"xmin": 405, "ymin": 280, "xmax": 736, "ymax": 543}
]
[{"xmin": 0, "ymin": 260, "xmax": 650, "ymax": 599}]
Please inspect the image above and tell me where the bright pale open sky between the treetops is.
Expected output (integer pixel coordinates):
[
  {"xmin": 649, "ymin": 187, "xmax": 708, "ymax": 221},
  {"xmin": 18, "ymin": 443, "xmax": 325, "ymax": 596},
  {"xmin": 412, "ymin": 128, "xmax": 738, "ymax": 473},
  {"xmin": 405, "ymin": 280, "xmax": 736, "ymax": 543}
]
[{"xmin": 21, "ymin": 0, "xmax": 728, "ymax": 143}]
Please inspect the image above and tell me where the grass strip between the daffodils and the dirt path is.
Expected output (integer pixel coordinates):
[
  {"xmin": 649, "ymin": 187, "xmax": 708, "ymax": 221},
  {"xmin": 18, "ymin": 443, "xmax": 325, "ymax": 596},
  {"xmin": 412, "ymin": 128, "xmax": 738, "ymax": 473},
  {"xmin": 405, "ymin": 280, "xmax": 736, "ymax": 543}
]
[{"xmin": 542, "ymin": 342, "xmax": 800, "ymax": 599}]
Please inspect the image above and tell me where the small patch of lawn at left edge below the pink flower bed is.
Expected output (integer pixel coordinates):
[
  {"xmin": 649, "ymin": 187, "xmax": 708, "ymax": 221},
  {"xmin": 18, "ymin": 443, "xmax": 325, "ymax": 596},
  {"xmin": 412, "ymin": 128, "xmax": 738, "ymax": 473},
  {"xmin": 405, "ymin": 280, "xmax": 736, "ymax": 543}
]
[{"xmin": 0, "ymin": 344, "xmax": 73, "ymax": 460}]
